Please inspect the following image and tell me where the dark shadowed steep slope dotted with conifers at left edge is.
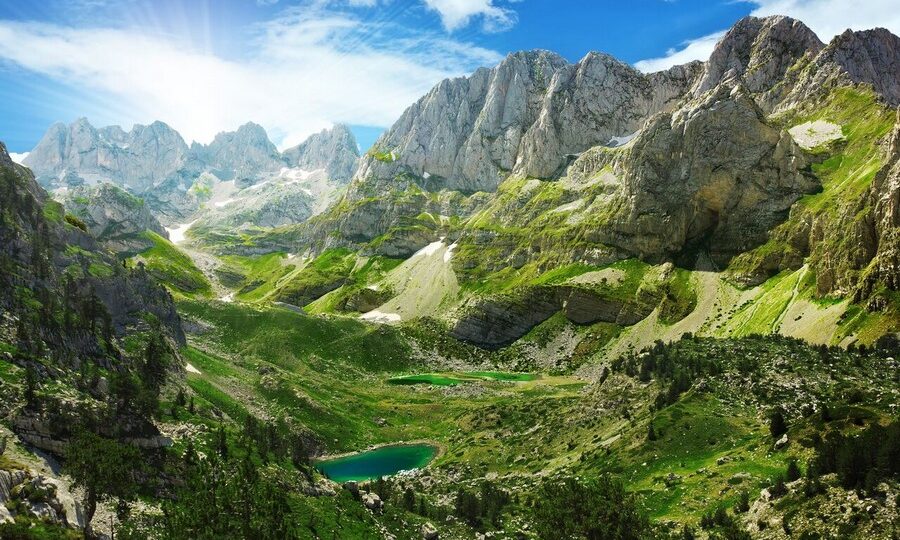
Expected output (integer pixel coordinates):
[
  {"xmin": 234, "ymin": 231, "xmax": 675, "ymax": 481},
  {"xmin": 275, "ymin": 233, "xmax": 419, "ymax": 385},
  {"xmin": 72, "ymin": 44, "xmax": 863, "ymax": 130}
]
[{"xmin": 0, "ymin": 140, "xmax": 184, "ymax": 354}]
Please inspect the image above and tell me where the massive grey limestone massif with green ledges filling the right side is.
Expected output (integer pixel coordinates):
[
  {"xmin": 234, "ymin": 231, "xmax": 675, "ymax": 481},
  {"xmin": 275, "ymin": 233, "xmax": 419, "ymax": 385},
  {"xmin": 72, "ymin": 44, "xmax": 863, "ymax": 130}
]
[{"xmin": 241, "ymin": 17, "xmax": 900, "ymax": 347}]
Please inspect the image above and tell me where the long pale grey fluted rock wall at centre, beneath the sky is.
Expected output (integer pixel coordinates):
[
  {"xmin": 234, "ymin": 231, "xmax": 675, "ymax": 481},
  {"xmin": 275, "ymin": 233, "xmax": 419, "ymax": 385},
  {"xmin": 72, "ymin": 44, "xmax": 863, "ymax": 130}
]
[{"xmin": 356, "ymin": 51, "xmax": 700, "ymax": 192}]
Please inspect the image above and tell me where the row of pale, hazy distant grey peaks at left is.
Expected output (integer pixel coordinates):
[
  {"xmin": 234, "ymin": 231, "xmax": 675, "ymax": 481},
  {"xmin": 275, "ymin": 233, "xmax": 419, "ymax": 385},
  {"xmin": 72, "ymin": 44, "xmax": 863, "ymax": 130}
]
[{"xmin": 27, "ymin": 119, "xmax": 359, "ymax": 227}]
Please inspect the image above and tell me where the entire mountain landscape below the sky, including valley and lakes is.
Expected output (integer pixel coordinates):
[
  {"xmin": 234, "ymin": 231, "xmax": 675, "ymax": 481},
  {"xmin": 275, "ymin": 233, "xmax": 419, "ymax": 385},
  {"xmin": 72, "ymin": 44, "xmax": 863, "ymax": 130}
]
[{"xmin": 0, "ymin": 12, "xmax": 900, "ymax": 540}]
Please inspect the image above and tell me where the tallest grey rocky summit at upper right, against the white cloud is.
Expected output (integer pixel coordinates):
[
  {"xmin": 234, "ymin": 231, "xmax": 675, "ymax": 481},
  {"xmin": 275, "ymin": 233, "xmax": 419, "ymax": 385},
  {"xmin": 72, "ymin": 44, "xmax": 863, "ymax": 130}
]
[{"xmin": 694, "ymin": 16, "xmax": 824, "ymax": 101}]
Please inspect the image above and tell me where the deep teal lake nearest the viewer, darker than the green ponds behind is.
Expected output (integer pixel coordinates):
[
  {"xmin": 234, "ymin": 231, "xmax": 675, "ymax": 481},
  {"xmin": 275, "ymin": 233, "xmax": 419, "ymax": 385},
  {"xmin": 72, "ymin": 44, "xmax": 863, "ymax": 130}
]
[{"xmin": 314, "ymin": 444, "xmax": 438, "ymax": 482}]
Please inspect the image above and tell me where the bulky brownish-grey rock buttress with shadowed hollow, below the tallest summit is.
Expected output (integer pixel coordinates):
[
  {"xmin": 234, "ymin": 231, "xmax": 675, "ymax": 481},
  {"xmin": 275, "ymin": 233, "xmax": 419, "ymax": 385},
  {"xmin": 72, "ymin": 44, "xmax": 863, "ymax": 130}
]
[{"xmin": 599, "ymin": 81, "xmax": 819, "ymax": 265}]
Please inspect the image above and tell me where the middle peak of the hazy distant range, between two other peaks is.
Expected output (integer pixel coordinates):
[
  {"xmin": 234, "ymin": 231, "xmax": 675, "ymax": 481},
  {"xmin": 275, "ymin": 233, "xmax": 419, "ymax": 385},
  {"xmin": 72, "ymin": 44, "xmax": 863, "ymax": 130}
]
[{"xmin": 194, "ymin": 122, "xmax": 284, "ymax": 180}]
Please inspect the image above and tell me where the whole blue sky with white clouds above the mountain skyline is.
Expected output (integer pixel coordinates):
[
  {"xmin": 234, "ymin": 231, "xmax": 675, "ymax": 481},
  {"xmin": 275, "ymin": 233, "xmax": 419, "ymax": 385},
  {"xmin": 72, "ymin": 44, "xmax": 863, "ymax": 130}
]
[{"xmin": 0, "ymin": 0, "xmax": 900, "ymax": 156}]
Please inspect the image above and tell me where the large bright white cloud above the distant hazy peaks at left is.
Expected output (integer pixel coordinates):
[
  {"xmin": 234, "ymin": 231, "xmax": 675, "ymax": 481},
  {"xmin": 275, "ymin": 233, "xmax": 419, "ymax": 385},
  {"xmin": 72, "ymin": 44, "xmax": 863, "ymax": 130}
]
[{"xmin": 0, "ymin": 2, "xmax": 501, "ymax": 148}]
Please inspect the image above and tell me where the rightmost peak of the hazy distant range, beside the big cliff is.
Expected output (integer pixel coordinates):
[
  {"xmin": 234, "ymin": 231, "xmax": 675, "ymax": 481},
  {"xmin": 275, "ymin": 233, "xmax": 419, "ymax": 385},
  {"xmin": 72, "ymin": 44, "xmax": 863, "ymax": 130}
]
[{"xmin": 282, "ymin": 124, "xmax": 359, "ymax": 182}]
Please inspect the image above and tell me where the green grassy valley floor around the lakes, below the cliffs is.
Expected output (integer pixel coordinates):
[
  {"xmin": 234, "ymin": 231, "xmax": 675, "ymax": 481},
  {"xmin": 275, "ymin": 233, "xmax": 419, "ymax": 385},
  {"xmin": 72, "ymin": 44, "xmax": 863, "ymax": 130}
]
[{"xmin": 172, "ymin": 301, "xmax": 893, "ymax": 536}]
